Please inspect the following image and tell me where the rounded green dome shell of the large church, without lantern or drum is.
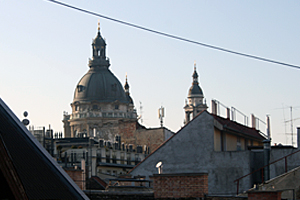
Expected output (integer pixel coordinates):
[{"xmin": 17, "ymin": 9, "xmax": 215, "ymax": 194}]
[{"xmin": 73, "ymin": 67, "xmax": 130, "ymax": 103}]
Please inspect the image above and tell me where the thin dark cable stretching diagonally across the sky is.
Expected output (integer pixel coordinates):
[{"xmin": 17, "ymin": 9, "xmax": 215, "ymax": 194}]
[{"xmin": 47, "ymin": 0, "xmax": 300, "ymax": 69}]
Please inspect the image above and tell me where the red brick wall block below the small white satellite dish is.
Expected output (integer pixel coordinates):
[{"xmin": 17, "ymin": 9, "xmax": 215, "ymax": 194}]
[{"xmin": 150, "ymin": 173, "xmax": 208, "ymax": 198}]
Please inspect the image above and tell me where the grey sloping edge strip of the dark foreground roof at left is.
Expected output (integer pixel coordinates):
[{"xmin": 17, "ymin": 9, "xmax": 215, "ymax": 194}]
[{"xmin": 0, "ymin": 98, "xmax": 89, "ymax": 199}]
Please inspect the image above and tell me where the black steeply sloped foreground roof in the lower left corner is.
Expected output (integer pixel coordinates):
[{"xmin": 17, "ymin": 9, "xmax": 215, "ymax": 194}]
[{"xmin": 0, "ymin": 98, "xmax": 88, "ymax": 199}]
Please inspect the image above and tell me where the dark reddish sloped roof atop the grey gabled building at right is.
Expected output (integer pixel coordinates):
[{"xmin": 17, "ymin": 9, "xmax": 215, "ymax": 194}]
[{"xmin": 211, "ymin": 114, "xmax": 265, "ymax": 140}]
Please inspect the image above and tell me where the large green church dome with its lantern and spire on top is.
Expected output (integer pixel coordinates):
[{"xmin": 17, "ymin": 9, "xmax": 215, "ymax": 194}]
[{"xmin": 73, "ymin": 23, "xmax": 130, "ymax": 103}]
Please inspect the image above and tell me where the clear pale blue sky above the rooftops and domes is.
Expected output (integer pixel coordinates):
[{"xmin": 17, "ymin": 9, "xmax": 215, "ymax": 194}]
[{"xmin": 0, "ymin": 0, "xmax": 300, "ymax": 144}]
